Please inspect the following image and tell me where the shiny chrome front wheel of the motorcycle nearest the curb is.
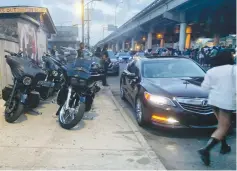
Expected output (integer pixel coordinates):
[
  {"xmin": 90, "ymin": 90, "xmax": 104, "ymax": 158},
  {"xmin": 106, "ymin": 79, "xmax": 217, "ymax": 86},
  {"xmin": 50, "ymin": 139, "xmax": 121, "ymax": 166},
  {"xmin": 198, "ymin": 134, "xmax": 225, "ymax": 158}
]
[{"xmin": 58, "ymin": 103, "xmax": 86, "ymax": 129}]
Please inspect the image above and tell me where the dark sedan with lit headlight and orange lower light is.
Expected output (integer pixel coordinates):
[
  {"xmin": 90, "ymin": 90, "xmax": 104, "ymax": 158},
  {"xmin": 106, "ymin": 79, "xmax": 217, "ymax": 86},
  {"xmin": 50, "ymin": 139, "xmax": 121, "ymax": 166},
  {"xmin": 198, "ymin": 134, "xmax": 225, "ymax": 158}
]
[{"xmin": 120, "ymin": 56, "xmax": 236, "ymax": 128}]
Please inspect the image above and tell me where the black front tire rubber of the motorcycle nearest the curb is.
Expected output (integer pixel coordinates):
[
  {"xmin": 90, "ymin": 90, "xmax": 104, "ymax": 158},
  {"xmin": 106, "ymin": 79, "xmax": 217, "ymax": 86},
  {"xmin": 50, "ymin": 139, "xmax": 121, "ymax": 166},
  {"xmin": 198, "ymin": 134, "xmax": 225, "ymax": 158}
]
[{"xmin": 58, "ymin": 103, "xmax": 86, "ymax": 129}]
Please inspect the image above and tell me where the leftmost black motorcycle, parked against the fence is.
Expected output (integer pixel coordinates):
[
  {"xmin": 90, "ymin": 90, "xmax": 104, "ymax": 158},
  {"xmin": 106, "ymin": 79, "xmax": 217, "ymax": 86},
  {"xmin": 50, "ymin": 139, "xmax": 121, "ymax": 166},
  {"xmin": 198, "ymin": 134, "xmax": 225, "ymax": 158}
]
[{"xmin": 2, "ymin": 50, "xmax": 46, "ymax": 123}]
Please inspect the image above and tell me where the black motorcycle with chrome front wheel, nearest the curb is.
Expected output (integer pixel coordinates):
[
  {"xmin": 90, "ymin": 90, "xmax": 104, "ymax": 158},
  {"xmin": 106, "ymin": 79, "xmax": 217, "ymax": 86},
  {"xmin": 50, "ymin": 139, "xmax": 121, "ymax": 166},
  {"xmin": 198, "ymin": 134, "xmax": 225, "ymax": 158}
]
[{"xmin": 50, "ymin": 56, "xmax": 102, "ymax": 129}]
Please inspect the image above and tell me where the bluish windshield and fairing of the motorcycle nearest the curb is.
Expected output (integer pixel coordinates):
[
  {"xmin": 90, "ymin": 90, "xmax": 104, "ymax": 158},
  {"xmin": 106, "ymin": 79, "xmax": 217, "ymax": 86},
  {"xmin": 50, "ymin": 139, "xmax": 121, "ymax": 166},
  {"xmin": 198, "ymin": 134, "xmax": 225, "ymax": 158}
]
[{"xmin": 66, "ymin": 59, "xmax": 93, "ymax": 79}]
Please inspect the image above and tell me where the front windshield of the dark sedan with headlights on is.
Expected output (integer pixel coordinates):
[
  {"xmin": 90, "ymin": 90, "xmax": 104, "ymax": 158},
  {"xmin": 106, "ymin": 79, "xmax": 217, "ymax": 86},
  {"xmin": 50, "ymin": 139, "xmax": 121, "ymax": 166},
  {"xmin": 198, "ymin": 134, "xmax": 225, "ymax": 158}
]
[{"xmin": 142, "ymin": 59, "xmax": 205, "ymax": 78}]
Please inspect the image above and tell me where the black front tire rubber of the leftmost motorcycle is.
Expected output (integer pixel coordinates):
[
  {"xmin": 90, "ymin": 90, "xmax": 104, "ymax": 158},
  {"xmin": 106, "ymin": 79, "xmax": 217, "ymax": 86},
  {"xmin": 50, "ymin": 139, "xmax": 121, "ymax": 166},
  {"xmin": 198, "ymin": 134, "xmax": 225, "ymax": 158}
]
[{"xmin": 4, "ymin": 99, "xmax": 24, "ymax": 123}]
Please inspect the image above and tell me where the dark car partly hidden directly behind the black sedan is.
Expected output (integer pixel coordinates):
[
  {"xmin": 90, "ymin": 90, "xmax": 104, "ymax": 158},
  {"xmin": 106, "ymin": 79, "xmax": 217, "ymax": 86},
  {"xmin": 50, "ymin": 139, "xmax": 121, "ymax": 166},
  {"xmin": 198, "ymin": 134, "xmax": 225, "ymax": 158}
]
[{"xmin": 108, "ymin": 50, "xmax": 120, "ymax": 76}]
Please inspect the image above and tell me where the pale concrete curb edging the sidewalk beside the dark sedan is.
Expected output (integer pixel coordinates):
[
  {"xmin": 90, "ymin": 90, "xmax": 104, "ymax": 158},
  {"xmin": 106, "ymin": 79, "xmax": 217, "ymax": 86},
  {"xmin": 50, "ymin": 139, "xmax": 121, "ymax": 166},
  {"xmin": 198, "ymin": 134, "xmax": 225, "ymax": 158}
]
[{"xmin": 109, "ymin": 89, "xmax": 167, "ymax": 170}]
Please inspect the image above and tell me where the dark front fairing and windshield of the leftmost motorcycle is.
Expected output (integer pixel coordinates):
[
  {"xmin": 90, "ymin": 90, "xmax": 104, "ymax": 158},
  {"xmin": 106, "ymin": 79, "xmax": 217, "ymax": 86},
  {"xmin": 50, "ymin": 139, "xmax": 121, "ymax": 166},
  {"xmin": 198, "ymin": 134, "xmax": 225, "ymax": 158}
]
[{"xmin": 6, "ymin": 56, "xmax": 42, "ymax": 78}]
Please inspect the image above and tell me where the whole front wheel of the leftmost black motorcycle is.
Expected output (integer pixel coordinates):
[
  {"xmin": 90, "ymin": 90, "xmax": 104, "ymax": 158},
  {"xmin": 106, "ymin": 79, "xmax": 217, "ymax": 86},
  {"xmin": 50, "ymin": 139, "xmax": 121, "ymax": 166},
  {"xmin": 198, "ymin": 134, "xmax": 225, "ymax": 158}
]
[{"xmin": 4, "ymin": 99, "xmax": 24, "ymax": 123}]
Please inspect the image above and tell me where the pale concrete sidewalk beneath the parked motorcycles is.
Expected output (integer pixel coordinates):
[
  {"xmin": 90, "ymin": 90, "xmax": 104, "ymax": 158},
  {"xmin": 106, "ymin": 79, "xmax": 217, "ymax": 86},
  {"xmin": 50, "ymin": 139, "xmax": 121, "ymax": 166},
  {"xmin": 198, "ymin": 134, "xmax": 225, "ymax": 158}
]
[{"xmin": 0, "ymin": 89, "xmax": 165, "ymax": 170}]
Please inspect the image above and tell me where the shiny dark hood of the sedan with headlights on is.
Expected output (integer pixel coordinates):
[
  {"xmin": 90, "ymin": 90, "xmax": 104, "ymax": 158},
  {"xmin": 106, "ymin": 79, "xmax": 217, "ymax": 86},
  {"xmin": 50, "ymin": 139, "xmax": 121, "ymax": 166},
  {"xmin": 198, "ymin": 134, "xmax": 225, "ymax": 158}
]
[{"xmin": 144, "ymin": 77, "xmax": 208, "ymax": 98}]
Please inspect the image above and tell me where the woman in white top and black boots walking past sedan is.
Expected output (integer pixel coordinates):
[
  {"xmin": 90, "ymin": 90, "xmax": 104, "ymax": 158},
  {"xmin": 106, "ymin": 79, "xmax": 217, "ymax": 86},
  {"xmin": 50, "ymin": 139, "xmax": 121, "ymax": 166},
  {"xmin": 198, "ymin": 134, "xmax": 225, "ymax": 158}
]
[{"xmin": 198, "ymin": 50, "xmax": 236, "ymax": 166}]
